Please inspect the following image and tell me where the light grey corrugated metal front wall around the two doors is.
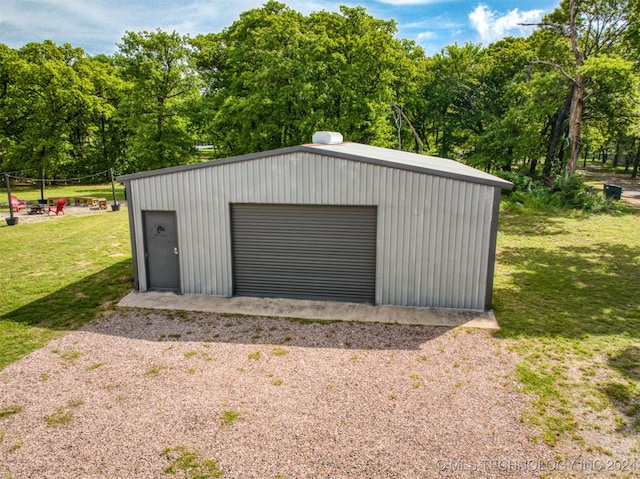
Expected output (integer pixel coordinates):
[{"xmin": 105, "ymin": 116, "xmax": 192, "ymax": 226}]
[{"xmin": 128, "ymin": 153, "xmax": 499, "ymax": 309}]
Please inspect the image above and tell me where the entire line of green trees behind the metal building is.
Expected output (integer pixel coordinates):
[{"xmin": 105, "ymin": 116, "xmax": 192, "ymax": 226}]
[{"xmin": 0, "ymin": 0, "xmax": 640, "ymax": 179}]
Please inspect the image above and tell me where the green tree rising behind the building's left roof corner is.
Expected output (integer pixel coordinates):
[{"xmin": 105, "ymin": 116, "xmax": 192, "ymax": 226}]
[{"xmin": 115, "ymin": 29, "xmax": 199, "ymax": 169}]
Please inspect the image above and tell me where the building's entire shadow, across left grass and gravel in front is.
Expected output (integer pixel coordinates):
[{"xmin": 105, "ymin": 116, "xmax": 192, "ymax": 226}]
[{"xmin": 0, "ymin": 259, "xmax": 452, "ymax": 352}]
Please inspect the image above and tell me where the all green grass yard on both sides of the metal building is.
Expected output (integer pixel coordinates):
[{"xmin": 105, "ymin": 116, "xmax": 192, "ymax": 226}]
[{"xmin": 0, "ymin": 193, "xmax": 640, "ymax": 455}]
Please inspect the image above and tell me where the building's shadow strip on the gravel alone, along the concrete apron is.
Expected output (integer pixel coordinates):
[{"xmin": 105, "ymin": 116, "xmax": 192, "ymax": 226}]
[{"xmin": 82, "ymin": 308, "xmax": 452, "ymax": 350}]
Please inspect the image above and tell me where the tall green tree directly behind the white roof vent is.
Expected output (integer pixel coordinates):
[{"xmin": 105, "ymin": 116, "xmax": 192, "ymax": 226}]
[{"xmin": 308, "ymin": 6, "xmax": 402, "ymax": 146}]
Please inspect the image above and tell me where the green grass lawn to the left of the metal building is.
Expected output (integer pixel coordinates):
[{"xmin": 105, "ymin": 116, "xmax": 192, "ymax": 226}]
[{"xmin": 0, "ymin": 208, "xmax": 131, "ymax": 369}]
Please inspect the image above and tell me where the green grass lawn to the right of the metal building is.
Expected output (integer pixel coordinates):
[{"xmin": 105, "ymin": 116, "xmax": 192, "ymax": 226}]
[{"xmin": 494, "ymin": 207, "xmax": 640, "ymax": 452}]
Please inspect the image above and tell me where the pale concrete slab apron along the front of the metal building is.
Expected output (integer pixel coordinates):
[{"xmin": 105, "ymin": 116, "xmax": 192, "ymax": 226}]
[{"xmin": 118, "ymin": 291, "xmax": 499, "ymax": 329}]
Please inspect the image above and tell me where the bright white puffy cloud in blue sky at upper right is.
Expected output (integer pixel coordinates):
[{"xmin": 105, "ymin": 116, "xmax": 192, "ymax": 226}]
[{"xmin": 469, "ymin": 4, "xmax": 544, "ymax": 43}]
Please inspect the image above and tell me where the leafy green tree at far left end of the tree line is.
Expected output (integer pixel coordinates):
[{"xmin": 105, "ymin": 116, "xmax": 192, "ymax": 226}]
[{"xmin": 1, "ymin": 41, "xmax": 103, "ymax": 182}]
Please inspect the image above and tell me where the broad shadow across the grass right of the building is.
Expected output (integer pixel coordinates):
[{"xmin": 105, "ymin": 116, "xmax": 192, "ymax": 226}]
[{"xmin": 494, "ymin": 244, "xmax": 640, "ymax": 339}]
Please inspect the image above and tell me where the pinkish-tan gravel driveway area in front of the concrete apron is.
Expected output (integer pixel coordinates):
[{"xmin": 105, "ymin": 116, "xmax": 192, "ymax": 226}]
[{"xmin": 0, "ymin": 309, "xmax": 553, "ymax": 479}]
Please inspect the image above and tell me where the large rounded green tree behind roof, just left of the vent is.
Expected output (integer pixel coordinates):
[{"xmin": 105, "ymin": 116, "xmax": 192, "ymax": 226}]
[{"xmin": 193, "ymin": 2, "xmax": 316, "ymax": 155}]
